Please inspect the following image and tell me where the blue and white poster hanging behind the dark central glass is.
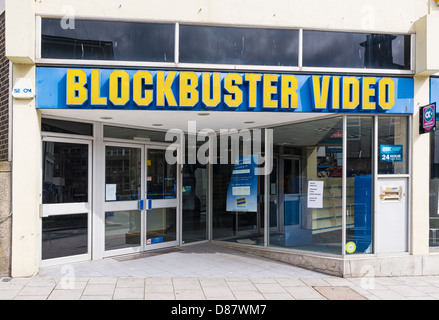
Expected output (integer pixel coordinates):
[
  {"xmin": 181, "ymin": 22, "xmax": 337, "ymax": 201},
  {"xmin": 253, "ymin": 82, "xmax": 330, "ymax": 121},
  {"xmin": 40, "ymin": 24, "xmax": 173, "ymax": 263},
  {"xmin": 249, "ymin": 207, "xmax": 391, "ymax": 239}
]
[{"xmin": 226, "ymin": 155, "xmax": 258, "ymax": 212}]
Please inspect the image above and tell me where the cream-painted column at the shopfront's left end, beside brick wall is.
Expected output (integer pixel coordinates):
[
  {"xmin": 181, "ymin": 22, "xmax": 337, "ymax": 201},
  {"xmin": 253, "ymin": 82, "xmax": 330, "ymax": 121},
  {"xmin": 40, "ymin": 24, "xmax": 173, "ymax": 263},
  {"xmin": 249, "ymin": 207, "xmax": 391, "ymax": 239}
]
[{"xmin": 11, "ymin": 64, "xmax": 41, "ymax": 277}]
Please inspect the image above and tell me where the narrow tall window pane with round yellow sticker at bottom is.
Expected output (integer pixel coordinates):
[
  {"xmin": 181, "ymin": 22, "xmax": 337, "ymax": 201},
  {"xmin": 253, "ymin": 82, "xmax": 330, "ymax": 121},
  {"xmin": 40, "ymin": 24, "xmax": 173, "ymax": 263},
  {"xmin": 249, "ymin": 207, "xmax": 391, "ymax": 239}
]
[{"xmin": 346, "ymin": 117, "xmax": 373, "ymax": 254}]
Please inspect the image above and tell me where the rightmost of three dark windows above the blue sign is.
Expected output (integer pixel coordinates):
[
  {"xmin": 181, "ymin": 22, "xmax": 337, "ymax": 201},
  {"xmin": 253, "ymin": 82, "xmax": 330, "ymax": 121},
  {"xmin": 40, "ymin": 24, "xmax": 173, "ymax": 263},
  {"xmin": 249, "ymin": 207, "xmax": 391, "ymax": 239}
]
[{"xmin": 303, "ymin": 31, "xmax": 411, "ymax": 70}]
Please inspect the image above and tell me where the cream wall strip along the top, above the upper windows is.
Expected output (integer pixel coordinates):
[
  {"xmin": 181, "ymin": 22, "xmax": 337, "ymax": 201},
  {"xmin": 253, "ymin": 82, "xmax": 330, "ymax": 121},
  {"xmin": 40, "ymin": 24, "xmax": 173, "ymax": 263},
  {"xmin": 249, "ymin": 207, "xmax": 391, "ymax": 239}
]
[{"xmin": 34, "ymin": 0, "xmax": 433, "ymax": 32}]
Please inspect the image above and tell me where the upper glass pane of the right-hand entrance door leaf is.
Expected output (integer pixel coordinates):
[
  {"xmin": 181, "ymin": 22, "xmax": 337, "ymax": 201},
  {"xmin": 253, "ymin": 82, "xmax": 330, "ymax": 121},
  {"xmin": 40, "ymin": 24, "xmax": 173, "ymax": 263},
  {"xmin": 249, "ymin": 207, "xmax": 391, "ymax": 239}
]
[{"xmin": 146, "ymin": 149, "xmax": 177, "ymax": 199}]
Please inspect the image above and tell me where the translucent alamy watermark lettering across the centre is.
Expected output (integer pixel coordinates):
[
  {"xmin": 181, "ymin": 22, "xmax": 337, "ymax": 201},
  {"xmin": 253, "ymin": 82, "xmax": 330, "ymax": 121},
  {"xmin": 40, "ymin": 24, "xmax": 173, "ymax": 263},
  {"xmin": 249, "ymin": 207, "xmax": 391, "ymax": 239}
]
[{"xmin": 165, "ymin": 121, "xmax": 273, "ymax": 175}]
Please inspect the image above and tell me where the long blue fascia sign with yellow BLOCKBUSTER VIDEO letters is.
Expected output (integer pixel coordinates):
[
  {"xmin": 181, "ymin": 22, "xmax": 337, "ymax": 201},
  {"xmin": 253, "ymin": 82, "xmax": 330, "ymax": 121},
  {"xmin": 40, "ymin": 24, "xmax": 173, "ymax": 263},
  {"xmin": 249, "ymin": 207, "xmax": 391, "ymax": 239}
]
[{"xmin": 36, "ymin": 67, "xmax": 414, "ymax": 114}]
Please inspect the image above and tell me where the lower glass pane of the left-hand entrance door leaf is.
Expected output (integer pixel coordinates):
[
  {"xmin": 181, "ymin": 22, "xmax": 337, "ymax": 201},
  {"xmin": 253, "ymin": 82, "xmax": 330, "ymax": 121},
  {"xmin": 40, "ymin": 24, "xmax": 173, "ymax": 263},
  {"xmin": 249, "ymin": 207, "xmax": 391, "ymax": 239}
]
[{"xmin": 105, "ymin": 210, "xmax": 141, "ymax": 250}]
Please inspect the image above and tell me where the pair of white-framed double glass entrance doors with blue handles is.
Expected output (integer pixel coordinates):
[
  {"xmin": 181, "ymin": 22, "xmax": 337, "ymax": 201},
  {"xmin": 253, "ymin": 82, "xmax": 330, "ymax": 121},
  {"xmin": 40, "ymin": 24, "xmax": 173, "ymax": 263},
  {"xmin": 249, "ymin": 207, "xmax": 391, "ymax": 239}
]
[{"xmin": 104, "ymin": 142, "xmax": 180, "ymax": 256}]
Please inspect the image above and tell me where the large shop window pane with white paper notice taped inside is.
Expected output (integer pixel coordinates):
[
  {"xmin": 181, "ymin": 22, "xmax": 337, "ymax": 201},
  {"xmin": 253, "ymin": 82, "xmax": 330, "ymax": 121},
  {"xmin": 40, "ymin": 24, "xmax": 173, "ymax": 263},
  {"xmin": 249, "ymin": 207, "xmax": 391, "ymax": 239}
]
[{"xmin": 269, "ymin": 117, "xmax": 343, "ymax": 254}]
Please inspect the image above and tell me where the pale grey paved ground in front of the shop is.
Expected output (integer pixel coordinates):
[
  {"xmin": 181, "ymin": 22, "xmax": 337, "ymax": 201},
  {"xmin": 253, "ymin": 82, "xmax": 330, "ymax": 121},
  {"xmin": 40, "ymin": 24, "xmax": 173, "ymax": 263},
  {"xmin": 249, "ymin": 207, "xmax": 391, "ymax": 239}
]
[{"xmin": 0, "ymin": 243, "xmax": 439, "ymax": 300}]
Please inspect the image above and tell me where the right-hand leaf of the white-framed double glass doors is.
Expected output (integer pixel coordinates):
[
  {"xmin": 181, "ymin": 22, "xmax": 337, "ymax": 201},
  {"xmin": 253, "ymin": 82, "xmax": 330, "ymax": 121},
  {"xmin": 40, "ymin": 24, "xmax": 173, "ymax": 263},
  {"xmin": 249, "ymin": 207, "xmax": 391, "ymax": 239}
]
[{"xmin": 145, "ymin": 146, "xmax": 180, "ymax": 249}]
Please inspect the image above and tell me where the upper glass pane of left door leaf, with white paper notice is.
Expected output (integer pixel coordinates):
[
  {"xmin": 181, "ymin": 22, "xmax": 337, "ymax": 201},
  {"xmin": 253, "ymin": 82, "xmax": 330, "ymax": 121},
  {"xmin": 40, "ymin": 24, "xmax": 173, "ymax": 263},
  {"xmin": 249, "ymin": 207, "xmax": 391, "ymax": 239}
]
[{"xmin": 105, "ymin": 146, "xmax": 141, "ymax": 201}]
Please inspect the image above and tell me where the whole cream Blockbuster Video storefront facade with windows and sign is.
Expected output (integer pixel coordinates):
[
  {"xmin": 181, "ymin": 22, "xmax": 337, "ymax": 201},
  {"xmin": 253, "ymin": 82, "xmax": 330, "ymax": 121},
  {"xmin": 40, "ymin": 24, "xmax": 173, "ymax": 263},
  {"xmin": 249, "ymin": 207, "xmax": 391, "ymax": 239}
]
[{"xmin": 6, "ymin": 1, "xmax": 439, "ymax": 277}]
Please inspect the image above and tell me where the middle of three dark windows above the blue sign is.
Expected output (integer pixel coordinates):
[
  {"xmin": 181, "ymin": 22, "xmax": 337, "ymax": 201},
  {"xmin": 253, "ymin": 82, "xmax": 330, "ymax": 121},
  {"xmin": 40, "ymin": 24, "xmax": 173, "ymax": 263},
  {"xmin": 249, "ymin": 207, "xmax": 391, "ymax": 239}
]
[{"xmin": 180, "ymin": 25, "xmax": 299, "ymax": 66}]
